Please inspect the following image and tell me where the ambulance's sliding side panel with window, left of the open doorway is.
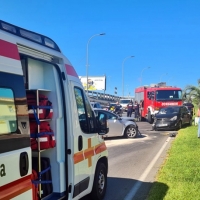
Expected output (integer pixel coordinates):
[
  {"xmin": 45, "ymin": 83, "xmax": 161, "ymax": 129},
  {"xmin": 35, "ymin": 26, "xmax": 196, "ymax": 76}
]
[{"xmin": 0, "ymin": 37, "xmax": 32, "ymax": 200}]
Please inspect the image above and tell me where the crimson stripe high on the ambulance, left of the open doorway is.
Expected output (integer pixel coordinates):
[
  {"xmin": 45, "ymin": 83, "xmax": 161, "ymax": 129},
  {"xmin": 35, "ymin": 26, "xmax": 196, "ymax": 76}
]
[{"xmin": 0, "ymin": 40, "xmax": 20, "ymax": 60}]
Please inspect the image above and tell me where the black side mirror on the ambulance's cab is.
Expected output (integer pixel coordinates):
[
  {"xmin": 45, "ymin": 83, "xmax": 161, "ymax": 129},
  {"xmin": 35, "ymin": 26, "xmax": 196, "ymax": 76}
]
[{"xmin": 97, "ymin": 111, "xmax": 109, "ymax": 135}]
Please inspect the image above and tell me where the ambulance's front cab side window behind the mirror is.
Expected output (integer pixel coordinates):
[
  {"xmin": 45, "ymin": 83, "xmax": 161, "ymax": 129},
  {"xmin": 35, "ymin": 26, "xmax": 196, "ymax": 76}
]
[{"xmin": 74, "ymin": 87, "xmax": 95, "ymax": 133}]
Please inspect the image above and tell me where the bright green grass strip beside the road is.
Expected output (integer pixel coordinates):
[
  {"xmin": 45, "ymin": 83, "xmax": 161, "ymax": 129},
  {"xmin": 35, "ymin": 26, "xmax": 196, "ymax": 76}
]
[{"xmin": 147, "ymin": 126, "xmax": 200, "ymax": 200}]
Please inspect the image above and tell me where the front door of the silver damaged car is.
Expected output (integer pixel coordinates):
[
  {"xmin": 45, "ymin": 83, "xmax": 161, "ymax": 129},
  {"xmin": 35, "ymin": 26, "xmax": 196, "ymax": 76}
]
[{"xmin": 105, "ymin": 112, "xmax": 123, "ymax": 137}]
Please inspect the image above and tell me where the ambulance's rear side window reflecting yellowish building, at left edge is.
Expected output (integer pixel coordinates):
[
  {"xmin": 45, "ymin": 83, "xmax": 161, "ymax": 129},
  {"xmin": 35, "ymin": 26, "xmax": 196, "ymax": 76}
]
[{"xmin": 0, "ymin": 88, "xmax": 17, "ymax": 134}]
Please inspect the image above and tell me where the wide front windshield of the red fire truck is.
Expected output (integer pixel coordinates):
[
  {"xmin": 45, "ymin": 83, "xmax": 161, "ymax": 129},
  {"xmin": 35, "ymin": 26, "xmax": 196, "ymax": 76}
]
[{"xmin": 156, "ymin": 90, "xmax": 182, "ymax": 101}]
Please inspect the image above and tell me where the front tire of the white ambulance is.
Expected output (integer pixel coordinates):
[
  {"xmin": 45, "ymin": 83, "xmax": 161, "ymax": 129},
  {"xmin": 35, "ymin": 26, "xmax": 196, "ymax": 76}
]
[{"xmin": 88, "ymin": 162, "xmax": 107, "ymax": 200}]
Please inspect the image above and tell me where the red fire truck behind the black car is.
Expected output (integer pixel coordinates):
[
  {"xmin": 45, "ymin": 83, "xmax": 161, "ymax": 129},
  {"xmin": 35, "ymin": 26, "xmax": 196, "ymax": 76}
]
[{"xmin": 135, "ymin": 84, "xmax": 182, "ymax": 123}]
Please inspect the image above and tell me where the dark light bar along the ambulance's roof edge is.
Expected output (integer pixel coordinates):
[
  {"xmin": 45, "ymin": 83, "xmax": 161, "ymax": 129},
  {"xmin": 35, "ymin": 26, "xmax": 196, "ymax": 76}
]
[{"xmin": 0, "ymin": 20, "xmax": 61, "ymax": 52}]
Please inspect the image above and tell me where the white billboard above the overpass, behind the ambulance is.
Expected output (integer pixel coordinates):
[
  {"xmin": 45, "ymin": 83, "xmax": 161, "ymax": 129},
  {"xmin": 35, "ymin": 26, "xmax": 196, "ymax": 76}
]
[{"xmin": 79, "ymin": 76, "xmax": 106, "ymax": 90}]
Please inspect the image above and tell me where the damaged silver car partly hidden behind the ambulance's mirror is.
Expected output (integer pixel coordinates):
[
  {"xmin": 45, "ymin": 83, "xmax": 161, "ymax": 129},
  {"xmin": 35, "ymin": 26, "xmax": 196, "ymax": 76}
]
[{"xmin": 94, "ymin": 109, "xmax": 139, "ymax": 138}]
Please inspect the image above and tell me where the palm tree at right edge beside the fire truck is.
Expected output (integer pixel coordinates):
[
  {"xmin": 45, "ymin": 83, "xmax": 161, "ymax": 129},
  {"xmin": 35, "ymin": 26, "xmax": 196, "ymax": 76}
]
[{"xmin": 182, "ymin": 79, "xmax": 200, "ymax": 104}]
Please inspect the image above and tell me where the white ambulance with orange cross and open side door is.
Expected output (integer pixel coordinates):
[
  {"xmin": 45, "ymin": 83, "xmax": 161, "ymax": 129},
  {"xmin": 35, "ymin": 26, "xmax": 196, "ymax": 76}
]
[{"xmin": 0, "ymin": 20, "xmax": 109, "ymax": 200}]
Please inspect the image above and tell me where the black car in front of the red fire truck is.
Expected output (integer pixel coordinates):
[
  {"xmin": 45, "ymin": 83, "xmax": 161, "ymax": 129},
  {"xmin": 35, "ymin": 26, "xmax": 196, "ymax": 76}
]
[{"xmin": 152, "ymin": 106, "xmax": 192, "ymax": 130}]
